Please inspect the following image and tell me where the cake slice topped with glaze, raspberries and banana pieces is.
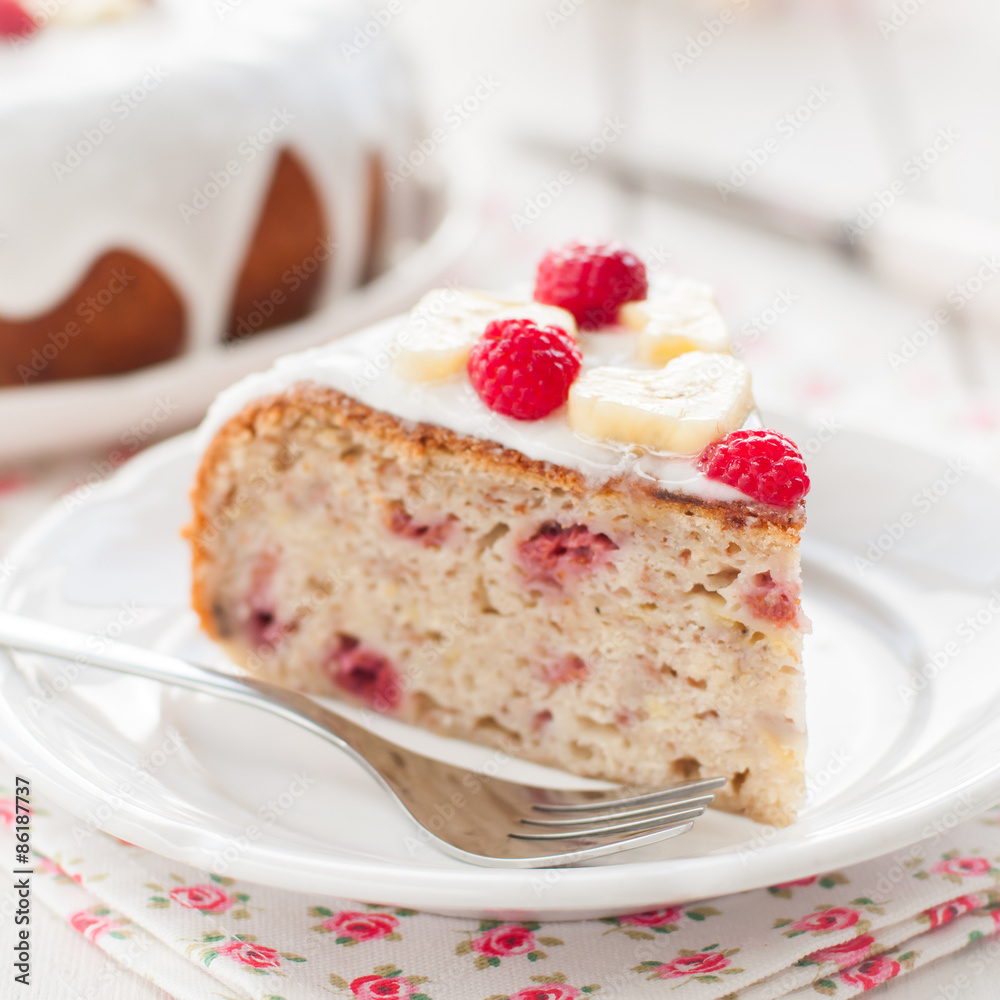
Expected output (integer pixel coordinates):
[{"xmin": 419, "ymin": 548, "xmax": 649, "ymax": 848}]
[{"xmin": 188, "ymin": 244, "xmax": 808, "ymax": 825}]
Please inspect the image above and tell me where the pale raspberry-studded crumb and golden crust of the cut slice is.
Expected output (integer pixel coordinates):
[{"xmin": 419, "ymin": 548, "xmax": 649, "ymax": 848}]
[{"xmin": 187, "ymin": 382, "xmax": 808, "ymax": 826}]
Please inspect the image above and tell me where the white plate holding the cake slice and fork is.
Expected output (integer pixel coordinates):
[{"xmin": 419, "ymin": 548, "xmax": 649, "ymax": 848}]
[{"xmin": 0, "ymin": 431, "xmax": 1000, "ymax": 919}]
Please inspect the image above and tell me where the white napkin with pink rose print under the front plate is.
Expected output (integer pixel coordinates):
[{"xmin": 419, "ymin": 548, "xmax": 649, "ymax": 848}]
[{"xmin": 0, "ymin": 769, "xmax": 1000, "ymax": 1000}]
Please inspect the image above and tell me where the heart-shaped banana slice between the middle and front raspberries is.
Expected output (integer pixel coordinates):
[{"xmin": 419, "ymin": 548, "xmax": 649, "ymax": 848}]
[{"xmin": 569, "ymin": 351, "xmax": 753, "ymax": 455}]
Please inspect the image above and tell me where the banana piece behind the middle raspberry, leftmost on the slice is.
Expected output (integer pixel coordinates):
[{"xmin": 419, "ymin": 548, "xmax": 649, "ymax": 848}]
[{"xmin": 395, "ymin": 288, "xmax": 576, "ymax": 382}]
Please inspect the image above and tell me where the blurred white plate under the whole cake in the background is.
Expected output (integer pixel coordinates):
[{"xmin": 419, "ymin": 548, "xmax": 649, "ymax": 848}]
[{"xmin": 0, "ymin": 183, "xmax": 477, "ymax": 462}]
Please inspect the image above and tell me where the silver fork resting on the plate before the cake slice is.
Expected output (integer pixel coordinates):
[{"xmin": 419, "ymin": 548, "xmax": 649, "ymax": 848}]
[{"xmin": 0, "ymin": 611, "xmax": 725, "ymax": 868}]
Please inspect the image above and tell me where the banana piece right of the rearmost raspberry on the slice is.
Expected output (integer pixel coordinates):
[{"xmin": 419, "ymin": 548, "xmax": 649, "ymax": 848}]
[{"xmin": 618, "ymin": 278, "xmax": 731, "ymax": 365}]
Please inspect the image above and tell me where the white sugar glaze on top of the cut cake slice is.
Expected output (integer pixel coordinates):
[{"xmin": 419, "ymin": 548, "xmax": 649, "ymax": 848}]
[{"xmin": 198, "ymin": 316, "xmax": 753, "ymax": 503}]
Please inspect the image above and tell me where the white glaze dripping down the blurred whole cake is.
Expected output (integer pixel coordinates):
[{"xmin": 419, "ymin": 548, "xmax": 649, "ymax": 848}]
[{"xmin": 0, "ymin": 0, "xmax": 426, "ymax": 350}]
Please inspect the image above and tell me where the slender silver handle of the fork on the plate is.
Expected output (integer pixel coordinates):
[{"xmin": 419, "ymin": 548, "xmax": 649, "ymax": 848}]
[{"xmin": 0, "ymin": 611, "xmax": 396, "ymax": 784}]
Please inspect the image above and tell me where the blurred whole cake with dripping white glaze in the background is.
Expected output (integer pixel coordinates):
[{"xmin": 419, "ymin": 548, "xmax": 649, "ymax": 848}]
[{"xmin": 0, "ymin": 0, "xmax": 433, "ymax": 386}]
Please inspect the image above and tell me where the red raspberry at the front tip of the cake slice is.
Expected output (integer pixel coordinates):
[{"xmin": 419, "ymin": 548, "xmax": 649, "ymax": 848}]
[{"xmin": 698, "ymin": 428, "xmax": 809, "ymax": 507}]
